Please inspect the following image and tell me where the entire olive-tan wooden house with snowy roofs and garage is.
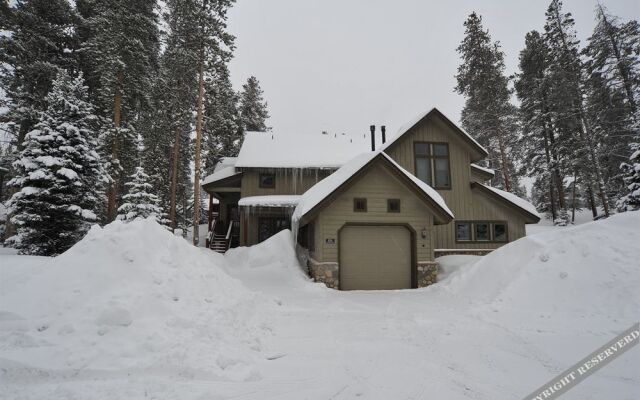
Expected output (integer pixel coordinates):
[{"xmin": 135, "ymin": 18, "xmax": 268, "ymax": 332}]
[{"xmin": 202, "ymin": 108, "xmax": 540, "ymax": 290}]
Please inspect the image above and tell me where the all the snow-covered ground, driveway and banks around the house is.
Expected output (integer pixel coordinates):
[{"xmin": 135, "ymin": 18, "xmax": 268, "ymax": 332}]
[{"xmin": 0, "ymin": 212, "xmax": 640, "ymax": 400}]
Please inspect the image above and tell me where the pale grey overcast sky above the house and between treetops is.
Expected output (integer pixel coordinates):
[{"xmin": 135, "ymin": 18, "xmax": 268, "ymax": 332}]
[{"xmin": 229, "ymin": 0, "xmax": 640, "ymax": 138}]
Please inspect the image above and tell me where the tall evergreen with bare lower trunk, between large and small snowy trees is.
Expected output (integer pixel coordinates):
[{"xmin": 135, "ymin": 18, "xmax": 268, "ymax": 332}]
[{"xmin": 79, "ymin": 0, "xmax": 159, "ymax": 221}]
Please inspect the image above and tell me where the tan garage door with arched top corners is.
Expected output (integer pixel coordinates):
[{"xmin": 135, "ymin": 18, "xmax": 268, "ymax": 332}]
[{"xmin": 339, "ymin": 226, "xmax": 411, "ymax": 290}]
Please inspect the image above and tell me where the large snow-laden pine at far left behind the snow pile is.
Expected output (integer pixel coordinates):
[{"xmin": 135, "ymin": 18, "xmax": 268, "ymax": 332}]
[{"xmin": 9, "ymin": 71, "xmax": 104, "ymax": 255}]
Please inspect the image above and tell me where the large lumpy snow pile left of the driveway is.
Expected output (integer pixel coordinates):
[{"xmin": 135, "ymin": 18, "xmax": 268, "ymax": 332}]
[{"xmin": 0, "ymin": 220, "xmax": 266, "ymax": 380}]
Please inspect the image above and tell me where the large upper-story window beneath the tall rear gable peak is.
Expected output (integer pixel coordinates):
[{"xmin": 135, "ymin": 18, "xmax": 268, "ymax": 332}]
[{"xmin": 413, "ymin": 142, "xmax": 451, "ymax": 189}]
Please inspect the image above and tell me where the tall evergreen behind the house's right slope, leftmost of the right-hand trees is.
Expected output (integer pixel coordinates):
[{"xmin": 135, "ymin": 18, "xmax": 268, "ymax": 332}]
[{"xmin": 455, "ymin": 12, "xmax": 518, "ymax": 192}]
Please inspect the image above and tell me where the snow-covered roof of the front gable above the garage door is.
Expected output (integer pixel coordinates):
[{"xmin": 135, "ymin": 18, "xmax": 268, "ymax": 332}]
[{"xmin": 291, "ymin": 151, "xmax": 453, "ymax": 223}]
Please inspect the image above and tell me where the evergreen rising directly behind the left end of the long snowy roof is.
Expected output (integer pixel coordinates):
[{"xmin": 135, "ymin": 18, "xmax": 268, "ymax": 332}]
[{"xmin": 204, "ymin": 64, "xmax": 243, "ymax": 173}]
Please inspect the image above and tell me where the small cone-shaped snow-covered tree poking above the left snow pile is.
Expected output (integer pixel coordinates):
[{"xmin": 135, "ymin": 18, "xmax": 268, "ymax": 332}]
[{"xmin": 117, "ymin": 167, "xmax": 162, "ymax": 222}]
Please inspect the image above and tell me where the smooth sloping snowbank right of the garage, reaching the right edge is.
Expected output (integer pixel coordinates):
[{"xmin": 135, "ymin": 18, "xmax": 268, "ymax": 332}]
[{"xmin": 444, "ymin": 212, "xmax": 640, "ymax": 320}]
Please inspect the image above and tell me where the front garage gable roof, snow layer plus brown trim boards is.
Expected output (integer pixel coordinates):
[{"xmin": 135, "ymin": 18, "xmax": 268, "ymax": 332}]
[{"xmin": 291, "ymin": 151, "xmax": 453, "ymax": 228}]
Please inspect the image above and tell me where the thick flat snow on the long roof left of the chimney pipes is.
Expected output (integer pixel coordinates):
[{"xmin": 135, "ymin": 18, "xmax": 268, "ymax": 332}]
[{"xmin": 236, "ymin": 132, "xmax": 371, "ymax": 168}]
